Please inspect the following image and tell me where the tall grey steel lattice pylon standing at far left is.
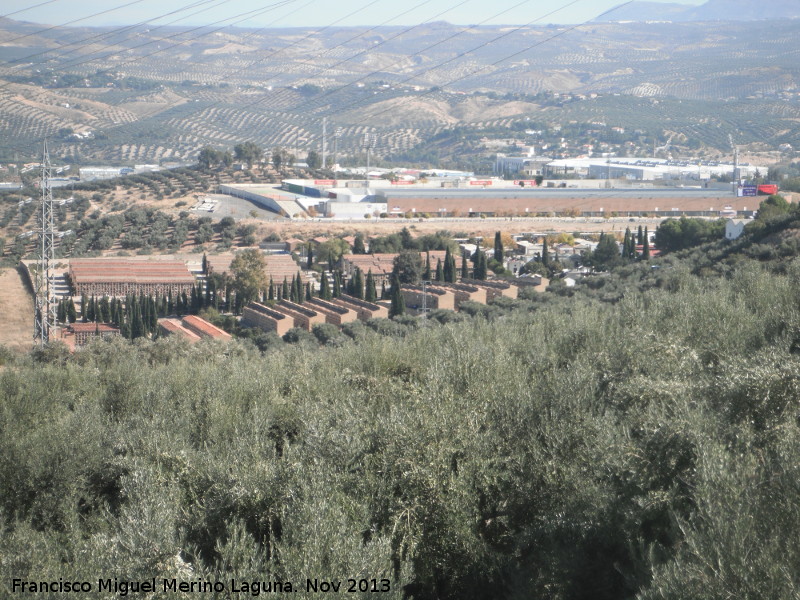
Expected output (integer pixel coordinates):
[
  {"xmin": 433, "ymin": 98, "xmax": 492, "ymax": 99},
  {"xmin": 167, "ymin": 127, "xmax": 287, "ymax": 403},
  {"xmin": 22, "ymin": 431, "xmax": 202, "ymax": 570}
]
[{"xmin": 33, "ymin": 141, "xmax": 57, "ymax": 346}]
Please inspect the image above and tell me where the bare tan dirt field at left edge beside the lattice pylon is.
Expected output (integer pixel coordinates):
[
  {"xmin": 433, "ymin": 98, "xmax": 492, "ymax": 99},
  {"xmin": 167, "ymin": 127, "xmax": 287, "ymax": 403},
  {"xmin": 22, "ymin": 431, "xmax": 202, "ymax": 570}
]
[{"xmin": 0, "ymin": 268, "xmax": 33, "ymax": 352}]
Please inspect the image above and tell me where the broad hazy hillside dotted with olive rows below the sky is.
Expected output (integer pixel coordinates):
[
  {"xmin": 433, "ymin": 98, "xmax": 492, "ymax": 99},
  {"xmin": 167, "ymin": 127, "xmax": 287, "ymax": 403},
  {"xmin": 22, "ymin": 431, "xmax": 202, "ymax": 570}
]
[{"xmin": 0, "ymin": 19, "xmax": 800, "ymax": 163}]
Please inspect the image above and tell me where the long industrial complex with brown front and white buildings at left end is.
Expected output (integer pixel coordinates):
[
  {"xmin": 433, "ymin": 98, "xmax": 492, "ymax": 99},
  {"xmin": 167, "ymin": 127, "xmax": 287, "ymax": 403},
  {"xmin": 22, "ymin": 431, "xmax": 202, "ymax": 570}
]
[{"xmin": 220, "ymin": 165, "xmax": 760, "ymax": 220}]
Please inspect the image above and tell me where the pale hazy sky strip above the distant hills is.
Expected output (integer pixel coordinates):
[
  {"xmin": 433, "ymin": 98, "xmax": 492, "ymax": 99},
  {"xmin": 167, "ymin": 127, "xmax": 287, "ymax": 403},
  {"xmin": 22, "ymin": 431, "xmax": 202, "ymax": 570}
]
[{"xmin": 0, "ymin": 0, "xmax": 705, "ymax": 27}]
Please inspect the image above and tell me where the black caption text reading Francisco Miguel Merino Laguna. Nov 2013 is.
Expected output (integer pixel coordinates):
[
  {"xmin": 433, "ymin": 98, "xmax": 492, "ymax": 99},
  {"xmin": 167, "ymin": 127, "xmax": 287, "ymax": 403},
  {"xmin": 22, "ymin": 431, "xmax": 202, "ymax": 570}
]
[{"xmin": 11, "ymin": 577, "xmax": 391, "ymax": 597}]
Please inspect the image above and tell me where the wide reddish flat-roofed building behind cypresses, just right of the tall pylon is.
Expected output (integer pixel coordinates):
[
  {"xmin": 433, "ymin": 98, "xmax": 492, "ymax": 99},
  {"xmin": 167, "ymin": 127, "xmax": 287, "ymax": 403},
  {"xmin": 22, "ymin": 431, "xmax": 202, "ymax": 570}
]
[{"xmin": 69, "ymin": 258, "xmax": 195, "ymax": 297}]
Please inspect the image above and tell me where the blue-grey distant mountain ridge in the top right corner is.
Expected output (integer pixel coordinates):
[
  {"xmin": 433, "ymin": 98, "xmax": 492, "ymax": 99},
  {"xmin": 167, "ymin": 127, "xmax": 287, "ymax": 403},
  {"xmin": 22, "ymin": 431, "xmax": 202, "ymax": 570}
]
[{"xmin": 601, "ymin": 0, "xmax": 800, "ymax": 22}]
